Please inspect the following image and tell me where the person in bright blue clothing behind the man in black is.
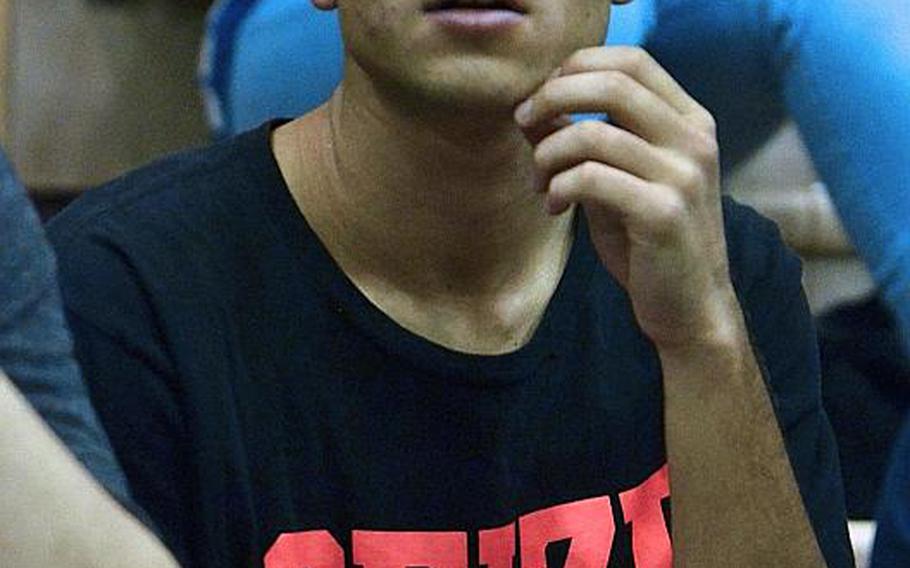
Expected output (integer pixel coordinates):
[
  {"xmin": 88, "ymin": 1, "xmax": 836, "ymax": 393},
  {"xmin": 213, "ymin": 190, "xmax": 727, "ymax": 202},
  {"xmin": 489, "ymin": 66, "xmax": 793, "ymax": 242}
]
[{"xmin": 200, "ymin": 0, "xmax": 910, "ymax": 518}]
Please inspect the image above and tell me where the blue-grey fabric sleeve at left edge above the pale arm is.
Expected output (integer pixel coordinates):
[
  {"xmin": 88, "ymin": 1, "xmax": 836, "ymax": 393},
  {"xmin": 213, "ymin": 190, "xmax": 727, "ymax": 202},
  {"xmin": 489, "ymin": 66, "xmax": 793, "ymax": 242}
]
[{"xmin": 0, "ymin": 149, "xmax": 134, "ymax": 504}]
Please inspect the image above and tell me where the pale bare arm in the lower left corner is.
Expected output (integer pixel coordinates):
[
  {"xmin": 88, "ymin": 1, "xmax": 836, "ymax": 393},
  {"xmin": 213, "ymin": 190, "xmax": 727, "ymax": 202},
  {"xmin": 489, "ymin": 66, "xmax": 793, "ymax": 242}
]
[{"xmin": 0, "ymin": 372, "xmax": 177, "ymax": 568}]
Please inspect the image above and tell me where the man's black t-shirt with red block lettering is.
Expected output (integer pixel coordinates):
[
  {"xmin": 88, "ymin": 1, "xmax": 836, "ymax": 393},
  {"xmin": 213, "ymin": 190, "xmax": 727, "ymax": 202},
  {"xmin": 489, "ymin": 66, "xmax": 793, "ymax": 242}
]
[{"xmin": 50, "ymin": 125, "xmax": 850, "ymax": 568}]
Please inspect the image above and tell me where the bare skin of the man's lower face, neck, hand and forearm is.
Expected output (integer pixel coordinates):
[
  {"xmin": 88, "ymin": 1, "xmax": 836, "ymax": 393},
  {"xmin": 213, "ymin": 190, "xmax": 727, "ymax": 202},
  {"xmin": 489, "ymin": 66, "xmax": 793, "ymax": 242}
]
[{"xmin": 273, "ymin": 0, "xmax": 824, "ymax": 567}]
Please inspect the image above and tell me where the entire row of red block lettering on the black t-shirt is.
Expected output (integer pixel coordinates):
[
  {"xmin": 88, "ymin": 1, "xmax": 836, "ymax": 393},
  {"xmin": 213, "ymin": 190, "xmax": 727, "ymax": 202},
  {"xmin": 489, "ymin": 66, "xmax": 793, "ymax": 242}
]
[{"xmin": 264, "ymin": 465, "xmax": 673, "ymax": 568}]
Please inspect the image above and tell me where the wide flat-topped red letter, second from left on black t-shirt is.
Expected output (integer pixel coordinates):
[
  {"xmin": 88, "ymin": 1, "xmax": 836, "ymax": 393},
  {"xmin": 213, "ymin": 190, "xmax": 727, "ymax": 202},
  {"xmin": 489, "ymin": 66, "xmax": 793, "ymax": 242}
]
[{"xmin": 353, "ymin": 531, "xmax": 468, "ymax": 568}]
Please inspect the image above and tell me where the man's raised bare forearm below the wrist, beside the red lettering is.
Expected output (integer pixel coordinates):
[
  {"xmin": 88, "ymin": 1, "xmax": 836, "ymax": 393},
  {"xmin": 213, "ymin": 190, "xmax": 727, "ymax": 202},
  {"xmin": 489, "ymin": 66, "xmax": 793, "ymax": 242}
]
[{"xmin": 659, "ymin": 310, "xmax": 825, "ymax": 568}]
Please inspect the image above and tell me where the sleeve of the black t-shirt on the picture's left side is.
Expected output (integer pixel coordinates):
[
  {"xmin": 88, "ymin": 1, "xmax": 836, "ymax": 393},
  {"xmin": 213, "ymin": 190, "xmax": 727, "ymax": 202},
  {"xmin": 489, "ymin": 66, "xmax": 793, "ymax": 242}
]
[{"xmin": 50, "ymin": 220, "xmax": 192, "ymax": 566}]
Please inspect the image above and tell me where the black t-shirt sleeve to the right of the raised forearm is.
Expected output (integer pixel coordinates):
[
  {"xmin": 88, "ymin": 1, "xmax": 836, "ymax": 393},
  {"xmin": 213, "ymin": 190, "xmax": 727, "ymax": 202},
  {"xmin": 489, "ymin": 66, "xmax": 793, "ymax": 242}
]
[{"xmin": 724, "ymin": 201, "xmax": 853, "ymax": 568}]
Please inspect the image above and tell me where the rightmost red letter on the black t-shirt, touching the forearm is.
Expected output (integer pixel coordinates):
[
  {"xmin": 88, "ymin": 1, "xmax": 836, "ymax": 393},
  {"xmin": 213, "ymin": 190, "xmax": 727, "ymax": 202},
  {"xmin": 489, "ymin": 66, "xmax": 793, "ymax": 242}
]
[{"xmin": 619, "ymin": 465, "xmax": 673, "ymax": 568}]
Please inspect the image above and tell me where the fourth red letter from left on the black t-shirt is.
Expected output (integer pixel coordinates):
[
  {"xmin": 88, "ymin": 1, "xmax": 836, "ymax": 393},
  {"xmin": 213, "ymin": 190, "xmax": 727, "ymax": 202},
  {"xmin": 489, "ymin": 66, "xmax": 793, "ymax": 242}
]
[{"xmin": 518, "ymin": 497, "xmax": 616, "ymax": 568}]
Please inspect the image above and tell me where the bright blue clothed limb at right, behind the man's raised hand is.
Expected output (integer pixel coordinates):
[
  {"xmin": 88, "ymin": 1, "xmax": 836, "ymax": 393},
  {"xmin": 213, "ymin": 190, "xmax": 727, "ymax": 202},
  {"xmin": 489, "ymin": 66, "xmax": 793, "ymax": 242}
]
[{"xmin": 645, "ymin": 0, "xmax": 910, "ymax": 353}]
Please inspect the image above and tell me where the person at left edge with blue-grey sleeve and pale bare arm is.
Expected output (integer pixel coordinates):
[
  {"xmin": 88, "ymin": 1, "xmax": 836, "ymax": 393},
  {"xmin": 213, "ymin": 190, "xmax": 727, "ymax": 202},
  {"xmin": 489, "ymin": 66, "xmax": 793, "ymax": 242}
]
[{"xmin": 0, "ymin": 149, "xmax": 176, "ymax": 568}]
